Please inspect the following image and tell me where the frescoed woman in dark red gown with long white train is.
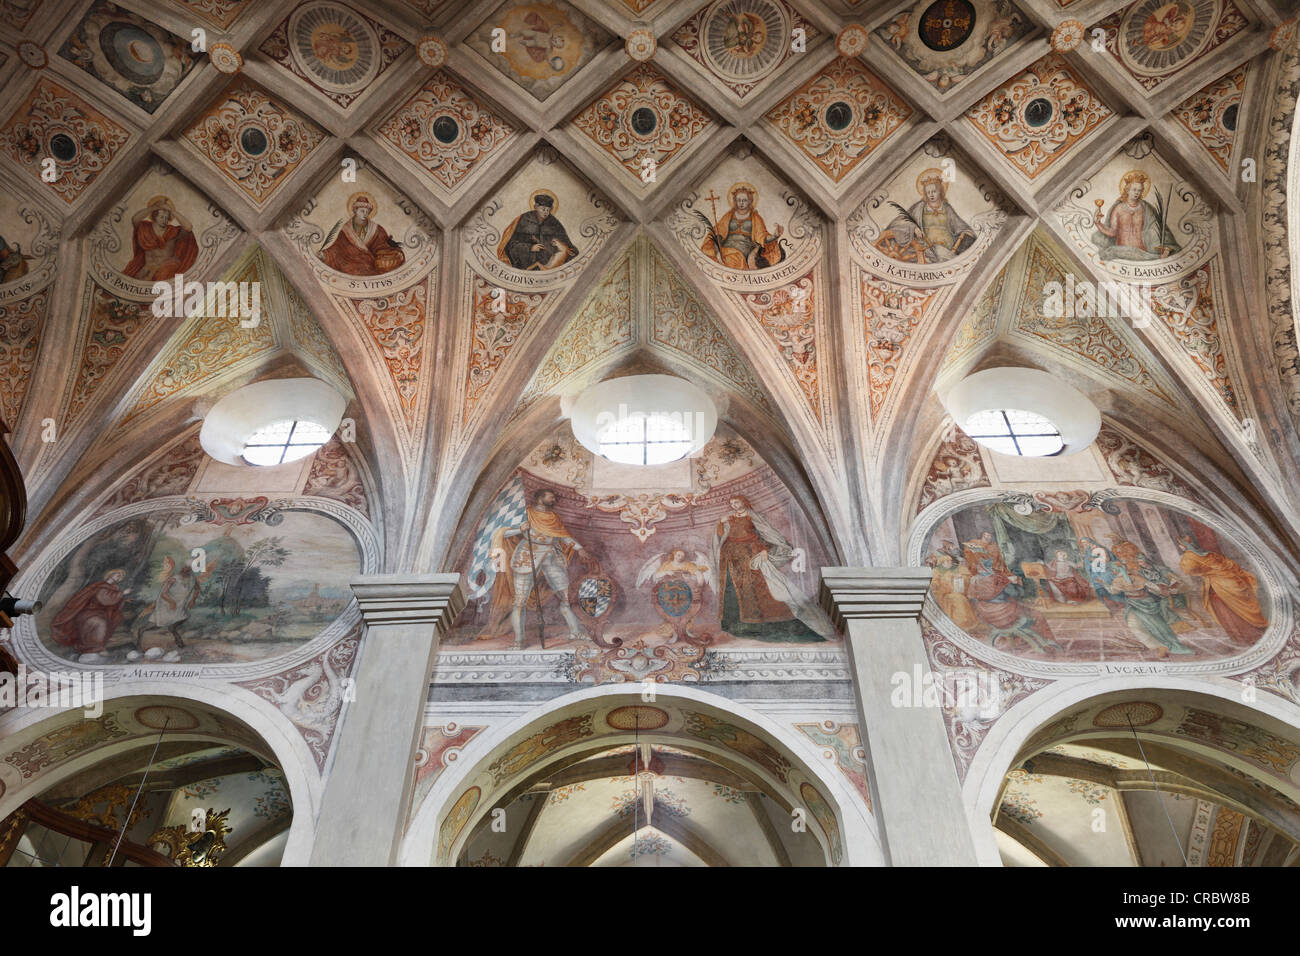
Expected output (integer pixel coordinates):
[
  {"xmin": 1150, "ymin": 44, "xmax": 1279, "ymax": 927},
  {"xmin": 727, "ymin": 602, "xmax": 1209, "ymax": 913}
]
[{"xmin": 711, "ymin": 496, "xmax": 835, "ymax": 643}]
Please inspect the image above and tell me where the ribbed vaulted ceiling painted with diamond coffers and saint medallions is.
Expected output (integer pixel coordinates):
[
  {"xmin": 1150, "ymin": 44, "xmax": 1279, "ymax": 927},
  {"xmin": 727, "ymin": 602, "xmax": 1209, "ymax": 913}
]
[{"xmin": 0, "ymin": 0, "xmax": 1300, "ymax": 570}]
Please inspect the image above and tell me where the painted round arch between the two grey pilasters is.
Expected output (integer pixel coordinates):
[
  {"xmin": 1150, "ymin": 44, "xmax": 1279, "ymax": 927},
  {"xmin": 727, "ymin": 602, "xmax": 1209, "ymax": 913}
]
[{"xmin": 398, "ymin": 684, "xmax": 884, "ymax": 866}]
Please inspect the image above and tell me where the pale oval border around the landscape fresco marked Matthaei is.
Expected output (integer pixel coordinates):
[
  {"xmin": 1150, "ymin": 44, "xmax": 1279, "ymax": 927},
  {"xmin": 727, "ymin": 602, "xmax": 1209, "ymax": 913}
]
[{"xmin": 13, "ymin": 496, "xmax": 380, "ymax": 683}]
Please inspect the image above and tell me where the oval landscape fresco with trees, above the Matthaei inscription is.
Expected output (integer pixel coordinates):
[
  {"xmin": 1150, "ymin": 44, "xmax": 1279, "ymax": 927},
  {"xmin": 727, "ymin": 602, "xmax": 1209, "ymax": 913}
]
[{"xmin": 36, "ymin": 509, "xmax": 360, "ymax": 663}]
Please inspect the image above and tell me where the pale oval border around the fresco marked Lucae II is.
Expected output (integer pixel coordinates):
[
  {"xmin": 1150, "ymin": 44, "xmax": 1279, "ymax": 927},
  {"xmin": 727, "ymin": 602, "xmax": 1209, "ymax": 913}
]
[{"xmin": 907, "ymin": 488, "xmax": 1295, "ymax": 678}]
